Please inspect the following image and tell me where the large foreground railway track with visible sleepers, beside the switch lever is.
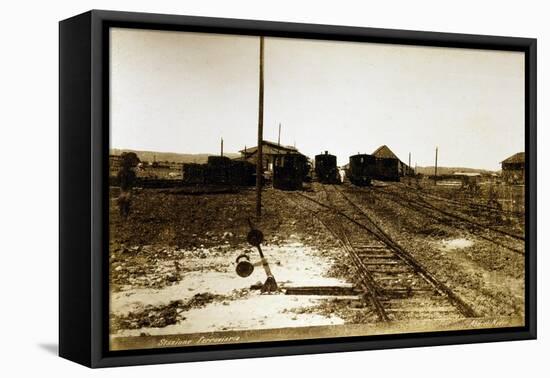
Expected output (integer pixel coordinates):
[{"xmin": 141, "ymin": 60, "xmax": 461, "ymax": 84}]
[{"xmin": 288, "ymin": 185, "xmax": 477, "ymax": 322}]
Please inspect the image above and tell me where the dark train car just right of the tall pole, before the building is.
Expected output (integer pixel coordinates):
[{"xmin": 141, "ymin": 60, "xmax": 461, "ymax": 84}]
[{"xmin": 273, "ymin": 153, "xmax": 310, "ymax": 190}]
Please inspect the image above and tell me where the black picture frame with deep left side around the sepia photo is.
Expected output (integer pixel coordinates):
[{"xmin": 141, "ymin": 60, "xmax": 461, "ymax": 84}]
[{"xmin": 59, "ymin": 10, "xmax": 537, "ymax": 367}]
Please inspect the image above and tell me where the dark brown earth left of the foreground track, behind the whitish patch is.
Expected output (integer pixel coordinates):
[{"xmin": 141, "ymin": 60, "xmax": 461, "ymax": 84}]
[{"xmin": 110, "ymin": 189, "xmax": 344, "ymax": 291}]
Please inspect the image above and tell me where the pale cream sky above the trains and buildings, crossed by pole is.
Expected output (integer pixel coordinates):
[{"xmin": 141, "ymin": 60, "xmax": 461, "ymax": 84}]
[{"xmin": 110, "ymin": 28, "xmax": 525, "ymax": 170}]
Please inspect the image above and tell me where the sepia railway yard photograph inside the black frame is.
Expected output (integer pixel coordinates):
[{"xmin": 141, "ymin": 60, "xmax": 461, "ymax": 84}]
[{"xmin": 108, "ymin": 27, "xmax": 527, "ymax": 351}]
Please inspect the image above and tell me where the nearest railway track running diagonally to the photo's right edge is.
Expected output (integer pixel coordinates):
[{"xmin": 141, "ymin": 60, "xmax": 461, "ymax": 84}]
[{"xmin": 362, "ymin": 182, "xmax": 525, "ymax": 255}]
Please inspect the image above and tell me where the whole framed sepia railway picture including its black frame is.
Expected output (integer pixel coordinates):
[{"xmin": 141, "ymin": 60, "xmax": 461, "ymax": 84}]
[{"xmin": 59, "ymin": 10, "xmax": 536, "ymax": 367}]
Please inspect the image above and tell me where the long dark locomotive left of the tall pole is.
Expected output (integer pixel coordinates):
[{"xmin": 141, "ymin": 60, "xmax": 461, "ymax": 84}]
[{"xmin": 183, "ymin": 156, "xmax": 256, "ymax": 186}]
